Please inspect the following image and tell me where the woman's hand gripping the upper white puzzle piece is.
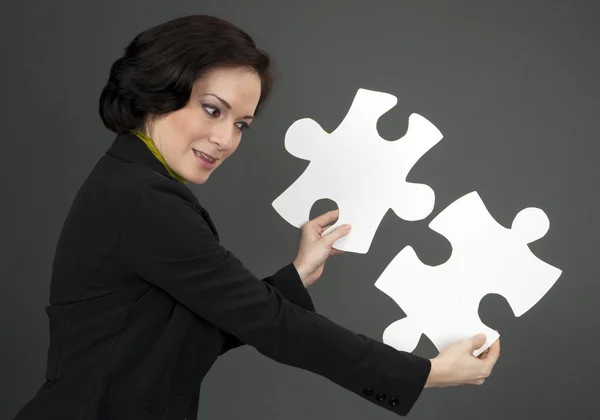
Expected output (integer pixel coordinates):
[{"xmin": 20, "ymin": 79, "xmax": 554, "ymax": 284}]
[{"xmin": 294, "ymin": 210, "xmax": 350, "ymax": 287}]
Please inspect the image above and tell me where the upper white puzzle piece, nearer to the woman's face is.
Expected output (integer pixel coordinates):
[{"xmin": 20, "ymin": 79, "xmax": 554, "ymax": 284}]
[{"xmin": 273, "ymin": 89, "xmax": 442, "ymax": 253}]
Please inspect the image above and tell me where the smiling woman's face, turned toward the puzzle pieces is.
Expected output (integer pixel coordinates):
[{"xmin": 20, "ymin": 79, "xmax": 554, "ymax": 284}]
[{"xmin": 145, "ymin": 68, "xmax": 261, "ymax": 184}]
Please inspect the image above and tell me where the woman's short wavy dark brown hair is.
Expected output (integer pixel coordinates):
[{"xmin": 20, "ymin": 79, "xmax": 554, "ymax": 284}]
[{"xmin": 99, "ymin": 15, "xmax": 275, "ymax": 133}]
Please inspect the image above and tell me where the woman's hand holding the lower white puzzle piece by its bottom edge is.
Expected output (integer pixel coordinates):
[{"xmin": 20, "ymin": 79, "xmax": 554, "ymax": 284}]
[{"xmin": 425, "ymin": 334, "xmax": 500, "ymax": 388}]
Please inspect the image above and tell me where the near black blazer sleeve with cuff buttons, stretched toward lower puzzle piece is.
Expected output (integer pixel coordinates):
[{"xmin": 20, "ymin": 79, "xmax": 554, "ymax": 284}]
[{"xmin": 120, "ymin": 179, "xmax": 431, "ymax": 415}]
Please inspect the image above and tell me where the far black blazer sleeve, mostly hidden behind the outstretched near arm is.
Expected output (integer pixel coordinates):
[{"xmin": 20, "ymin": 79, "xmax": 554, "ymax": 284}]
[{"xmin": 221, "ymin": 263, "xmax": 315, "ymax": 355}]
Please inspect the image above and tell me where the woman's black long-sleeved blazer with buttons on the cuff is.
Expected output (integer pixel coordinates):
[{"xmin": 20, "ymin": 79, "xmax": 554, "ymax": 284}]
[{"xmin": 11, "ymin": 134, "xmax": 431, "ymax": 420}]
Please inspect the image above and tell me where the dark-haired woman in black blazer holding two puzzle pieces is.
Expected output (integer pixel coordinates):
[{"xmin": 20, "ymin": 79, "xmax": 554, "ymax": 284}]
[{"xmin": 16, "ymin": 16, "xmax": 499, "ymax": 420}]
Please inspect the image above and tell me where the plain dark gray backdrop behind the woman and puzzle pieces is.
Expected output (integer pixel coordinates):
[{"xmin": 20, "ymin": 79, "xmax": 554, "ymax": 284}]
[{"xmin": 0, "ymin": 0, "xmax": 600, "ymax": 420}]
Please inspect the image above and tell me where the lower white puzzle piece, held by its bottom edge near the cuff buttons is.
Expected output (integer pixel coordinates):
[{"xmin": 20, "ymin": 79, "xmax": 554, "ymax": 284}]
[{"xmin": 375, "ymin": 192, "xmax": 562, "ymax": 356}]
